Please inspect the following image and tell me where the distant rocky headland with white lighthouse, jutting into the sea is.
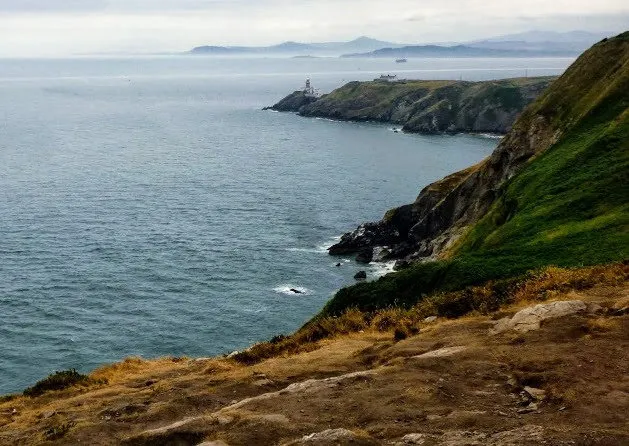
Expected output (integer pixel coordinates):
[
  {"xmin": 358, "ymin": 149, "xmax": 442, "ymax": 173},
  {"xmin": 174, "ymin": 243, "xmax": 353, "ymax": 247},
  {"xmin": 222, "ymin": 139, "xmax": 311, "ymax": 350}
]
[{"xmin": 270, "ymin": 77, "xmax": 554, "ymax": 134}]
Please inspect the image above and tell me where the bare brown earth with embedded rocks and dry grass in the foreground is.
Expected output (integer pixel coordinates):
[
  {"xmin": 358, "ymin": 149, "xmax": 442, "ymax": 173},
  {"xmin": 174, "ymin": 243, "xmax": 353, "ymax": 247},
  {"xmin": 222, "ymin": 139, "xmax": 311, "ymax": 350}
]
[{"xmin": 0, "ymin": 284, "xmax": 629, "ymax": 446}]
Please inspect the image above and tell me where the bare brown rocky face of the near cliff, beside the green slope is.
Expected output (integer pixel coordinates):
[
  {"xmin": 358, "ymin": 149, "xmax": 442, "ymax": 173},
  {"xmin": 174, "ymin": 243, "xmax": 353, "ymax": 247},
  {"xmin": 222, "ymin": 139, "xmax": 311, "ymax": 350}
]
[{"xmin": 330, "ymin": 36, "xmax": 629, "ymax": 261}]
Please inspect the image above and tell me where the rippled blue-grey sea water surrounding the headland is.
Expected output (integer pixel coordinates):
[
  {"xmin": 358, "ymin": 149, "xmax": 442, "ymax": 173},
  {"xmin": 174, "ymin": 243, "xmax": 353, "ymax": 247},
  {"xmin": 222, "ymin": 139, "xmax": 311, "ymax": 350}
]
[{"xmin": 0, "ymin": 57, "xmax": 571, "ymax": 393}]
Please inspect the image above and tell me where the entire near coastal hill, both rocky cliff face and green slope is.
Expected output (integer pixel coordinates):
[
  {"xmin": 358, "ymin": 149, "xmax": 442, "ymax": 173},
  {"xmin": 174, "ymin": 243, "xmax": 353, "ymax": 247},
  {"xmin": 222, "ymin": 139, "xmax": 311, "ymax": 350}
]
[{"xmin": 323, "ymin": 33, "xmax": 629, "ymax": 314}]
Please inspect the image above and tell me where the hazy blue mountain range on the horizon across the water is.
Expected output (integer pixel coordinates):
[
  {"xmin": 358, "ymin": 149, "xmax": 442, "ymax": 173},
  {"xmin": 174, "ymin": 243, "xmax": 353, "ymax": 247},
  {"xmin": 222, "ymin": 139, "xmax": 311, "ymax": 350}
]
[{"xmin": 188, "ymin": 31, "xmax": 608, "ymax": 58}]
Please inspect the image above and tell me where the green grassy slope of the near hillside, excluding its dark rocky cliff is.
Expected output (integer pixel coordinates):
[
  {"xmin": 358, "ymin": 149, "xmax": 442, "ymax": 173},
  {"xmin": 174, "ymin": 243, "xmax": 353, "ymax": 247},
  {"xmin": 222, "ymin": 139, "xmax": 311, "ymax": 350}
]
[{"xmin": 323, "ymin": 33, "xmax": 629, "ymax": 314}]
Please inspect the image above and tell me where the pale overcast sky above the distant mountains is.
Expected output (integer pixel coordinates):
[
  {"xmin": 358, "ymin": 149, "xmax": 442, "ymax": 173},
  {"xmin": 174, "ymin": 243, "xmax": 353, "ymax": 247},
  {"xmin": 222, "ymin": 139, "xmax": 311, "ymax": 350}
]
[{"xmin": 0, "ymin": 0, "xmax": 629, "ymax": 56}]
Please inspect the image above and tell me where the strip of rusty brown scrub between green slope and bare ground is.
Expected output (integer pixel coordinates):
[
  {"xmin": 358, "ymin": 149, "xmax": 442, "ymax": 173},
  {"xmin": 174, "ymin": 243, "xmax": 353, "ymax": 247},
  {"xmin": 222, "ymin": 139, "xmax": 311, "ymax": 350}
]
[{"xmin": 234, "ymin": 263, "xmax": 629, "ymax": 364}]
